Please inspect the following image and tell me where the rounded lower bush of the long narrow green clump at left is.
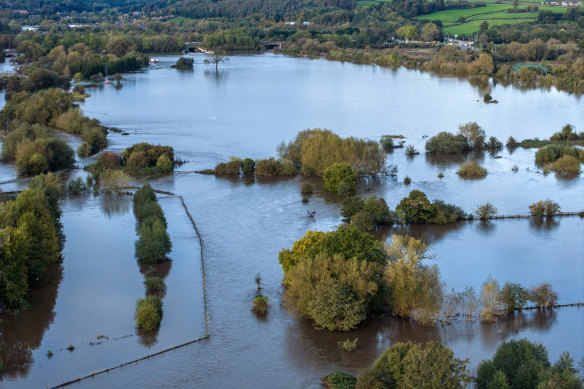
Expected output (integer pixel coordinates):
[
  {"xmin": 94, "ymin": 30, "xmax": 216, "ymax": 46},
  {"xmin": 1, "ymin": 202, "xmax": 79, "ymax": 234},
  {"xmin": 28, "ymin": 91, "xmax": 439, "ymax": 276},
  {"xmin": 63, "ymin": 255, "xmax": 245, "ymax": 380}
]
[{"xmin": 136, "ymin": 220, "xmax": 172, "ymax": 264}]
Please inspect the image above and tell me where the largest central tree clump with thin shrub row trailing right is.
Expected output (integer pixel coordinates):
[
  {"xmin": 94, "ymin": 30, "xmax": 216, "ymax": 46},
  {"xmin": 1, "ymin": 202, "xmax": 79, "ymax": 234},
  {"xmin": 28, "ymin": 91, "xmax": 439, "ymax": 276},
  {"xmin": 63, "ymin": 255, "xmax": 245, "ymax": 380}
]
[{"xmin": 278, "ymin": 225, "xmax": 558, "ymax": 331}]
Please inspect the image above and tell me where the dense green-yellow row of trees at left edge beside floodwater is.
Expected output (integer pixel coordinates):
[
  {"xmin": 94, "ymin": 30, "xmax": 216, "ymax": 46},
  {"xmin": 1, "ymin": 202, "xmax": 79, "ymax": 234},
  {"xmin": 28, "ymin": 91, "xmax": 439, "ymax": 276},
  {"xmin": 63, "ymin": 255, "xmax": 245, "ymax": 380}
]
[{"xmin": 0, "ymin": 174, "xmax": 64, "ymax": 309}]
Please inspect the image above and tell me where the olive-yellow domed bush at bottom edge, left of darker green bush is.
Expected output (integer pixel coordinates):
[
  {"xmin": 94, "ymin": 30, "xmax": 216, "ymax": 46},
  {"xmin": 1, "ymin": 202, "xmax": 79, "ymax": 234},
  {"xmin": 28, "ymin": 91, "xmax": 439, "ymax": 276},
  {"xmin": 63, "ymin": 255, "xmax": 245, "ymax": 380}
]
[{"xmin": 356, "ymin": 341, "xmax": 472, "ymax": 389}]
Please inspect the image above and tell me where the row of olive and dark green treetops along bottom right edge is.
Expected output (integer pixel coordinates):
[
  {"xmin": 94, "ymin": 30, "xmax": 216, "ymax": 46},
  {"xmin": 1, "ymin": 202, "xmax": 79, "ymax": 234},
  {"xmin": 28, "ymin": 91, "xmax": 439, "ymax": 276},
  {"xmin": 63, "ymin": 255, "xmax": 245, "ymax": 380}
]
[{"xmin": 322, "ymin": 339, "xmax": 582, "ymax": 389}]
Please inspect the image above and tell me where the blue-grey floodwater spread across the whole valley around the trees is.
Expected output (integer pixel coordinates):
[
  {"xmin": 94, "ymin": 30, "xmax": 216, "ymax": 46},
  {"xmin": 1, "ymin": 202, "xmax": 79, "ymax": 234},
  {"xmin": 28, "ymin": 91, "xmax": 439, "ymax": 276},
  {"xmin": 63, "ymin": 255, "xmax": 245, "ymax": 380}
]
[{"xmin": 0, "ymin": 54, "xmax": 584, "ymax": 388}]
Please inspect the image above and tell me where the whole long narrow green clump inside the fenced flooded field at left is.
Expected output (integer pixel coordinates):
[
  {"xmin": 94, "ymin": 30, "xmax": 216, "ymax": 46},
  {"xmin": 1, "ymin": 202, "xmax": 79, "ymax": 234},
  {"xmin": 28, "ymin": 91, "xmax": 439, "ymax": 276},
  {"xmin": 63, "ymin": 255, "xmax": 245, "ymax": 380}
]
[{"xmin": 133, "ymin": 184, "xmax": 172, "ymax": 264}]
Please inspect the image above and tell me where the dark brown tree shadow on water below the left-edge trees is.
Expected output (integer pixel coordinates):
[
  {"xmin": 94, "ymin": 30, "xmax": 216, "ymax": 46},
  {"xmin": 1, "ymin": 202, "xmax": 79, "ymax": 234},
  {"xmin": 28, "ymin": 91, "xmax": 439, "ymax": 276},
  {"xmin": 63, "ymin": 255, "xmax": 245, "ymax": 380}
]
[{"xmin": 0, "ymin": 264, "xmax": 63, "ymax": 377}]
